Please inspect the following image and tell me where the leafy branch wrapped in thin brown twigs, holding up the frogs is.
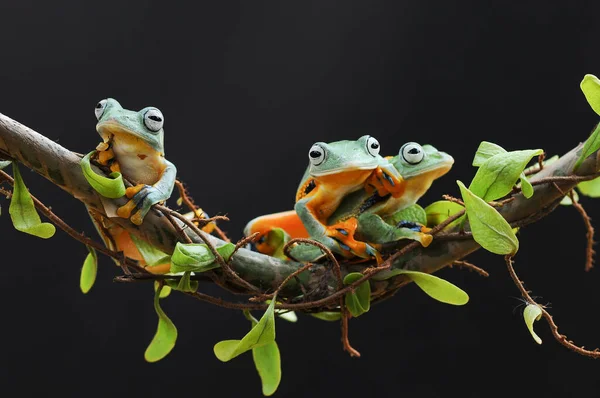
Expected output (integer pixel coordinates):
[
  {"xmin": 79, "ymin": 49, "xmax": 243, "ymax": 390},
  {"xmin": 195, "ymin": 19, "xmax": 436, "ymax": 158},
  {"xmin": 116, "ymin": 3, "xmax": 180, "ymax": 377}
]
[{"xmin": 0, "ymin": 75, "xmax": 600, "ymax": 395}]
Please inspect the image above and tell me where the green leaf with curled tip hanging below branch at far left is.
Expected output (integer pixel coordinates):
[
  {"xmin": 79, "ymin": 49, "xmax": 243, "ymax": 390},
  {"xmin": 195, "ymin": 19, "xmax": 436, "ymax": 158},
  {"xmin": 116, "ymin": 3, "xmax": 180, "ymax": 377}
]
[{"xmin": 8, "ymin": 162, "xmax": 56, "ymax": 239}]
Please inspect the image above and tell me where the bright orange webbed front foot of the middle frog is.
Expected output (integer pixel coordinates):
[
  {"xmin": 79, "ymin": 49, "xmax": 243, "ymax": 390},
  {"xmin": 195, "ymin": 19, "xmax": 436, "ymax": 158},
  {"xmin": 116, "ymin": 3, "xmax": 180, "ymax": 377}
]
[{"xmin": 320, "ymin": 217, "xmax": 381, "ymax": 263}]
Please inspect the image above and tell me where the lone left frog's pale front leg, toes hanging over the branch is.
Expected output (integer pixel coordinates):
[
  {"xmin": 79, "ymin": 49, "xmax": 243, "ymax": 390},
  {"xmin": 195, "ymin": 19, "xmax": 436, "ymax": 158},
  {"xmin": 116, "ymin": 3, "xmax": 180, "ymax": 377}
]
[{"xmin": 117, "ymin": 160, "xmax": 177, "ymax": 225}]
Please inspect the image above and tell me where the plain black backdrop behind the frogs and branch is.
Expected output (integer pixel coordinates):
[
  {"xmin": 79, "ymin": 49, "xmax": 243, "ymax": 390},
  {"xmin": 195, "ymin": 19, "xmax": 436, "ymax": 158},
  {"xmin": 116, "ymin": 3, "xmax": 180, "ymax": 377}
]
[{"xmin": 0, "ymin": 0, "xmax": 600, "ymax": 397}]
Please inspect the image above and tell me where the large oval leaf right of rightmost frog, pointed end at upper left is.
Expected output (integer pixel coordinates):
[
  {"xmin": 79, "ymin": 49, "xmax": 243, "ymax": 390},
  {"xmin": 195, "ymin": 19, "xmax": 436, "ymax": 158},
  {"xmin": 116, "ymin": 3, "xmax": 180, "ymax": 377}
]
[{"xmin": 456, "ymin": 181, "xmax": 519, "ymax": 255}]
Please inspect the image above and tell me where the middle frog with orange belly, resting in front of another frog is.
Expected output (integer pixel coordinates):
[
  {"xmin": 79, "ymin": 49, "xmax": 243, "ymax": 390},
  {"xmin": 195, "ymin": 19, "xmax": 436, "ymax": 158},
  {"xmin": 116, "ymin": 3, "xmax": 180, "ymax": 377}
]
[{"xmin": 245, "ymin": 135, "xmax": 404, "ymax": 258}]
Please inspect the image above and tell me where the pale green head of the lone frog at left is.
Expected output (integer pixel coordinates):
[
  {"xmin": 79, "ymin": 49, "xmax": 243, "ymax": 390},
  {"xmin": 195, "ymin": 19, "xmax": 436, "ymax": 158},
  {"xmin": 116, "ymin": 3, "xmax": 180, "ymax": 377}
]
[{"xmin": 94, "ymin": 98, "xmax": 165, "ymax": 155}]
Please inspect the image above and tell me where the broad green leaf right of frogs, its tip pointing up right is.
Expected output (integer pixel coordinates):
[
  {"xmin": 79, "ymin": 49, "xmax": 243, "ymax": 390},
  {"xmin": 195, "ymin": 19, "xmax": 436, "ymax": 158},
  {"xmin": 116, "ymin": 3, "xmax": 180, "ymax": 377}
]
[{"xmin": 469, "ymin": 149, "xmax": 544, "ymax": 201}]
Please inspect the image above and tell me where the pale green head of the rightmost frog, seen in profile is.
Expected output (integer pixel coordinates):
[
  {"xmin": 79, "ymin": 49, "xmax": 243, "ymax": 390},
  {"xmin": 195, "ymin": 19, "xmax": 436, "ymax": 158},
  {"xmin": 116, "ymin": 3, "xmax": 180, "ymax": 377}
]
[{"xmin": 390, "ymin": 142, "xmax": 454, "ymax": 185}]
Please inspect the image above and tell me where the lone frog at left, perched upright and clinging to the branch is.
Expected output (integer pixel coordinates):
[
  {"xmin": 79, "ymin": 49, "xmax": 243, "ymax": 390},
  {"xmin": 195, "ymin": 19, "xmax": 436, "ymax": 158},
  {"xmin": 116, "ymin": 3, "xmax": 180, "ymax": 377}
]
[{"xmin": 95, "ymin": 98, "xmax": 177, "ymax": 225}]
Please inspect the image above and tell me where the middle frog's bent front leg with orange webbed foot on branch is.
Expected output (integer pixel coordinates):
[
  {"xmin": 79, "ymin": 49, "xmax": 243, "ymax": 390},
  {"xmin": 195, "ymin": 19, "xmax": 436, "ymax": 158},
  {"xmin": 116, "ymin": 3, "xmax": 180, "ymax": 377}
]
[{"xmin": 294, "ymin": 198, "xmax": 379, "ymax": 258}]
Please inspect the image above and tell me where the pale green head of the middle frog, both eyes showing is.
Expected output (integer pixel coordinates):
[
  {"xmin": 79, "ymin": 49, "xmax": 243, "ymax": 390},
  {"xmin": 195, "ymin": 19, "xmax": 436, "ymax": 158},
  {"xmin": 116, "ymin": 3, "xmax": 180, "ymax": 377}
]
[{"xmin": 308, "ymin": 135, "xmax": 382, "ymax": 177}]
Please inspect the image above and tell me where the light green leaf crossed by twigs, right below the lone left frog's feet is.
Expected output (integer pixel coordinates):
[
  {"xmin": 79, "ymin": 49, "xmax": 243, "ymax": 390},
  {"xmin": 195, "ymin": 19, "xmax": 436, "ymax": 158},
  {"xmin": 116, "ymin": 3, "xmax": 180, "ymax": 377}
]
[{"xmin": 171, "ymin": 242, "xmax": 235, "ymax": 273}]
